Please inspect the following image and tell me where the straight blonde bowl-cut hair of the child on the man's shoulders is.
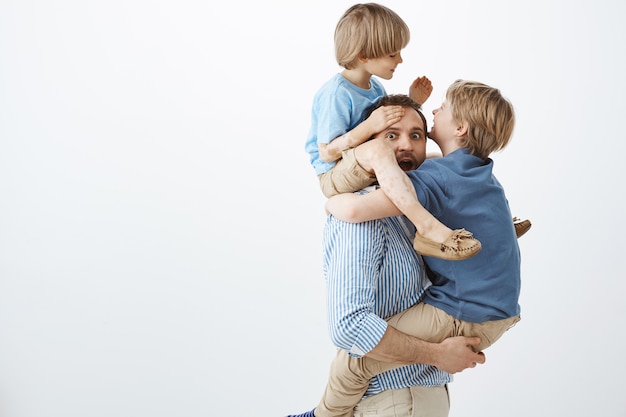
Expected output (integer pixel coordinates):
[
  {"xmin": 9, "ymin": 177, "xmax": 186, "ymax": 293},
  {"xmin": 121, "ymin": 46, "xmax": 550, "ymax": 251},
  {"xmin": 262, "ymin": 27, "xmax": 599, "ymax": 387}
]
[{"xmin": 335, "ymin": 3, "xmax": 411, "ymax": 69}]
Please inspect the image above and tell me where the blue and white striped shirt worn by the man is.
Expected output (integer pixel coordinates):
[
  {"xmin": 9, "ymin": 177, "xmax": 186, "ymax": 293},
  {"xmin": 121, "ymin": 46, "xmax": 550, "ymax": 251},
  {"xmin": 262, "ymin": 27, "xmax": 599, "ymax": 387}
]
[{"xmin": 323, "ymin": 211, "xmax": 451, "ymax": 395}]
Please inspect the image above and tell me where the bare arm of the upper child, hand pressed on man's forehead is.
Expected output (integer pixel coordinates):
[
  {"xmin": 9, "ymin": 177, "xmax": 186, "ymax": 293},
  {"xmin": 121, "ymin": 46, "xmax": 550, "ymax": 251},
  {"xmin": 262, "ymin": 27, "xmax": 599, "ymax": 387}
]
[{"xmin": 318, "ymin": 106, "xmax": 404, "ymax": 162}]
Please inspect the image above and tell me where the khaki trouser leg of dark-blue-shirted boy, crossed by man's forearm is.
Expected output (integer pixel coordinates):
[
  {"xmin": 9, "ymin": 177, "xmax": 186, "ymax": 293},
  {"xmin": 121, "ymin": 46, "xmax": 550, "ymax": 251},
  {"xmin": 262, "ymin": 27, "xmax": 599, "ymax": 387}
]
[{"xmin": 315, "ymin": 303, "xmax": 454, "ymax": 417}]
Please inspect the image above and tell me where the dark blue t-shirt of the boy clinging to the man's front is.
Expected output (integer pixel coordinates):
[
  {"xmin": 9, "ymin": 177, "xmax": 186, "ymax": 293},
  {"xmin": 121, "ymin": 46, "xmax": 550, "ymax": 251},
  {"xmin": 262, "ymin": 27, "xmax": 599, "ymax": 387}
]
[{"xmin": 408, "ymin": 149, "xmax": 521, "ymax": 323}]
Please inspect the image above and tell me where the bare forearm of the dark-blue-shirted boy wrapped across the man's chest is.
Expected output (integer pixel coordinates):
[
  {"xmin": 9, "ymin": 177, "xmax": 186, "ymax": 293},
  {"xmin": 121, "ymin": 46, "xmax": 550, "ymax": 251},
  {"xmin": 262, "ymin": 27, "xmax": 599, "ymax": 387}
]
[{"xmin": 326, "ymin": 190, "xmax": 402, "ymax": 223}]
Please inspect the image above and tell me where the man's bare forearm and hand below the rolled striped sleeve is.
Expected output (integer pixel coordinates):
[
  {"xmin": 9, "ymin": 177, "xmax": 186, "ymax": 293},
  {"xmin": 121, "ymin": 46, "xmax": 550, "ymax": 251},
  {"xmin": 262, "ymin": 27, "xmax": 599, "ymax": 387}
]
[{"xmin": 366, "ymin": 326, "xmax": 485, "ymax": 374}]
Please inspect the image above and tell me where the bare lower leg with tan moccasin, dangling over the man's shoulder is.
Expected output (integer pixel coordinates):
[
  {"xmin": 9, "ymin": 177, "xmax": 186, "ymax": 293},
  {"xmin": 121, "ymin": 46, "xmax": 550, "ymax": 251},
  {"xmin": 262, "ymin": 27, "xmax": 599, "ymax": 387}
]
[{"xmin": 355, "ymin": 139, "xmax": 481, "ymax": 260}]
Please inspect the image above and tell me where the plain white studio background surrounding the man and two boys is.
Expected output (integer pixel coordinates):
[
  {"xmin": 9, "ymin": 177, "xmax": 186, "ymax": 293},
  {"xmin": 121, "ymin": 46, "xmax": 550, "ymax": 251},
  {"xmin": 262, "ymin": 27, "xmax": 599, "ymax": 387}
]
[{"xmin": 0, "ymin": 0, "xmax": 626, "ymax": 417}]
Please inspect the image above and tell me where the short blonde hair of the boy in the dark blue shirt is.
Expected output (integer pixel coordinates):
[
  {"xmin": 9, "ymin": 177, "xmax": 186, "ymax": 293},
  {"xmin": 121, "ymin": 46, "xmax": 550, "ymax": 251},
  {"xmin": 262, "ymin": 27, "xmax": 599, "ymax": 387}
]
[{"xmin": 446, "ymin": 80, "xmax": 515, "ymax": 159}]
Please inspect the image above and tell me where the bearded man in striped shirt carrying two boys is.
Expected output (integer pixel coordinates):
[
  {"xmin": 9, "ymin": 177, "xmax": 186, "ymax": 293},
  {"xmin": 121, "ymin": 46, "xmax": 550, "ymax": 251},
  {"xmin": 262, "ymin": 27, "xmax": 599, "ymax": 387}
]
[{"xmin": 288, "ymin": 96, "xmax": 485, "ymax": 417}]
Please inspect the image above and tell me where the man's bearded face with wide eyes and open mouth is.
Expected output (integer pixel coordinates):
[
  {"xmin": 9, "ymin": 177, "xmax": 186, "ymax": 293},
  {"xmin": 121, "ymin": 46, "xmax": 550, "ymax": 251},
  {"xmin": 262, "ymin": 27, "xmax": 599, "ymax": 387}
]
[{"xmin": 374, "ymin": 107, "xmax": 426, "ymax": 172}]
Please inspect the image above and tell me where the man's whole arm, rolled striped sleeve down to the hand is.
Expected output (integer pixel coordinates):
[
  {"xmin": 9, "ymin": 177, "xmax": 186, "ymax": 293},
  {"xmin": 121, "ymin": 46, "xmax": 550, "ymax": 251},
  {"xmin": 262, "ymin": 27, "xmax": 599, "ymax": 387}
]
[{"xmin": 324, "ymin": 217, "xmax": 485, "ymax": 373}]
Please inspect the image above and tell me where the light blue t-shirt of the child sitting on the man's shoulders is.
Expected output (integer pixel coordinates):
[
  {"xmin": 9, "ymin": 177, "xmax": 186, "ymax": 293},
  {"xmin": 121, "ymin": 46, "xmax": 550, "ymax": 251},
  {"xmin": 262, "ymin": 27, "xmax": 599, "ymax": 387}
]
[{"xmin": 305, "ymin": 74, "xmax": 387, "ymax": 175}]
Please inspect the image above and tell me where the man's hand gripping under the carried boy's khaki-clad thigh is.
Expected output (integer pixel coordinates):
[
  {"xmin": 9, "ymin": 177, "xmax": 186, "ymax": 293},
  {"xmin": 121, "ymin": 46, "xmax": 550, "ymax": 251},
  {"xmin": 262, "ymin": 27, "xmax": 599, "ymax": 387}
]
[{"xmin": 432, "ymin": 336, "xmax": 485, "ymax": 374}]
